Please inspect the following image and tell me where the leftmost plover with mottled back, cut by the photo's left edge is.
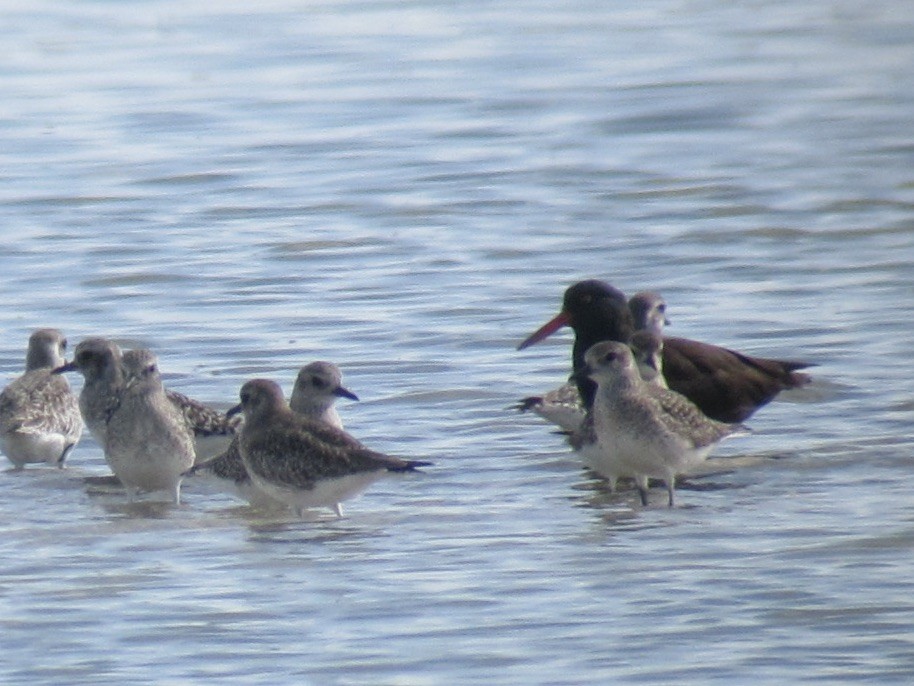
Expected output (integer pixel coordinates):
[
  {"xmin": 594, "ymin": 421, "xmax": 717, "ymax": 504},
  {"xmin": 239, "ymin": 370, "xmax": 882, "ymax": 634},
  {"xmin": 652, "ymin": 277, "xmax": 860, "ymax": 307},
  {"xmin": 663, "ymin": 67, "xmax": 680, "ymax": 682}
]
[{"xmin": 0, "ymin": 329, "xmax": 83, "ymax": 469}]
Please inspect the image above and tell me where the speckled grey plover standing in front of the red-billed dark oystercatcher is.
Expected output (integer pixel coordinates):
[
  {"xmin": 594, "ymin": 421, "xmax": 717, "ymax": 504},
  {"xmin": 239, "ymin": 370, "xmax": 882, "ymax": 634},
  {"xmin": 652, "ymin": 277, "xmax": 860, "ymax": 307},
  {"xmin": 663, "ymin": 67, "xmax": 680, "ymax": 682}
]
[{"xmin": 580, "ymin": 341, "xmax": 745, "ymax": 507}]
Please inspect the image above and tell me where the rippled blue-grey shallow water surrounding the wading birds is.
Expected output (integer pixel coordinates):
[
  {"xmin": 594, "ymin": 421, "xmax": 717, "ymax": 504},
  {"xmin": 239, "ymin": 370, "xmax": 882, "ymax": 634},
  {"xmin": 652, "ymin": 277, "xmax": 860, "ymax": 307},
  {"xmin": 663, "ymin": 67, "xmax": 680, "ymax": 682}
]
[{"xmin": 0, "ymin": 0, "xmax": 914, "ymax": 684}]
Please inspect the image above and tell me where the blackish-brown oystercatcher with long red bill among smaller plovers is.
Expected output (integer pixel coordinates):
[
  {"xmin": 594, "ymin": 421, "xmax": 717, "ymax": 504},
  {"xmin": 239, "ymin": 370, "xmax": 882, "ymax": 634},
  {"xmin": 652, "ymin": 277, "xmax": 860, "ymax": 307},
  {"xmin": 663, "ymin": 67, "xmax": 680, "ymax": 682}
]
[{"xmin": 518, "ymin": 280, "xmax": 811, "ymax": 422}]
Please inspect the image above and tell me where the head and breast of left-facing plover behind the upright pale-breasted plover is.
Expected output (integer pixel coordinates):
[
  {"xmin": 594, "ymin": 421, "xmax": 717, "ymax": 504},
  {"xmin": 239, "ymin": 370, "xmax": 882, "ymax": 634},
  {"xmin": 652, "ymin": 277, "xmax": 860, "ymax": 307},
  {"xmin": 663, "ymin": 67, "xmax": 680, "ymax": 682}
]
[{"xmin": 54, "ymin": 336, "xmax": 124, "ymax": 447}]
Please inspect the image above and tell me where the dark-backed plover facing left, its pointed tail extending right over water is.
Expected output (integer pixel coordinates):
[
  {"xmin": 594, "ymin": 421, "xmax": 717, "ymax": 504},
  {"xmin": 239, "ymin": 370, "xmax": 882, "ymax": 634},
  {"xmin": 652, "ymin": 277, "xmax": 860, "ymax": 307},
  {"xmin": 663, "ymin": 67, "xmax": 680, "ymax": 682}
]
[{"xmin": 229, "ymin": 379, "xmax": 429, "ymax": 515}]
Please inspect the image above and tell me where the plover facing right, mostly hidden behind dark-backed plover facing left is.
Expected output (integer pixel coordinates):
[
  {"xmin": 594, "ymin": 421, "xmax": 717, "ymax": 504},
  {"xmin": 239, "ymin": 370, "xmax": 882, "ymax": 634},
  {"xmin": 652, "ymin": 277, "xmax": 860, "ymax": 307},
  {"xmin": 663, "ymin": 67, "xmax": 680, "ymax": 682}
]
[{"xmin": 190, "ymin": 361, "xmax": 359, "ymax": 508}]
